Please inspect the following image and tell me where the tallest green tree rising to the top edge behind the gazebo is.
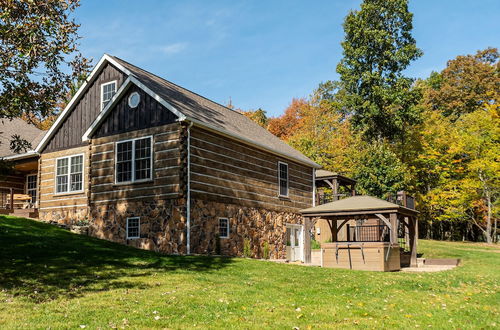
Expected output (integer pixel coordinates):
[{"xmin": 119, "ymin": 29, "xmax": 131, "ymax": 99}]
[{"xmin": 337, "ymin": 0, "xmax": 422, "ymax": 141}]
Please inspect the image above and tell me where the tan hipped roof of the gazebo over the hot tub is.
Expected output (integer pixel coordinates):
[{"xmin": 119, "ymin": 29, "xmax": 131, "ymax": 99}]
[{"xmin": 300, "ymin": 196, "xmax": 418, "ymax": 216}]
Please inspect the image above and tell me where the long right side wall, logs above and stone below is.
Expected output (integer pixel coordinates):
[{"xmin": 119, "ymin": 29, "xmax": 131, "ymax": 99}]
[{"xmin": 190, "ymin": 127, "xmax": 313, "ymax": 259}]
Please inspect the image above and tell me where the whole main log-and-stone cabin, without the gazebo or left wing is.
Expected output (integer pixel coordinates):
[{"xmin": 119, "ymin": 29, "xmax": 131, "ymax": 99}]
[{"xmin": 0, "ymin": 55, "xmax": 320, "ymax": 261}]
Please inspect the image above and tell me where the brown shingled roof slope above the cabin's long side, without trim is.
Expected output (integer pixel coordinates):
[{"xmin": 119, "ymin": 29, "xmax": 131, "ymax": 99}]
[{"xmin": 111, "ymin": 56, "xmax": 319, "ymax": 167}]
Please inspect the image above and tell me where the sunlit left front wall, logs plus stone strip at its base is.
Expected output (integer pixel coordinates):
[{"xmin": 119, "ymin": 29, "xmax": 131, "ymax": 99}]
[{"xmin": 39, "ymin": 146, "xmax": 90, "ymax": 223}]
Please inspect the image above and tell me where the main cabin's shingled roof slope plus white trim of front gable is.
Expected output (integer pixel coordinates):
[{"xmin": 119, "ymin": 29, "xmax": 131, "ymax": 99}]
[{"xmin": 78, "ymin": 55, "xmax": 321, "ymax": 168}]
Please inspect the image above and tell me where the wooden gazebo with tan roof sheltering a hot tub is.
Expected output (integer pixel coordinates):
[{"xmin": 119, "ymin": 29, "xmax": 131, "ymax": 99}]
[{"xmin": 300, "ymin": 196, "xmax": 418, "ymax": 271}]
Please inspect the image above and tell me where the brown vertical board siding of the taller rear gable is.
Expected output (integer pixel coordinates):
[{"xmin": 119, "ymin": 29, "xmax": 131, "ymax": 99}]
[{"xmin": 42, "ymin": 64, "xmax": 126, "ymax": 152}]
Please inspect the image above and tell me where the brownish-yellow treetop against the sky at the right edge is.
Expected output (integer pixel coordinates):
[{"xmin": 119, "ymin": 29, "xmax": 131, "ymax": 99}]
[{"xmin": 424, "ymin": 48, "xmax": 500, "ymax": 119}]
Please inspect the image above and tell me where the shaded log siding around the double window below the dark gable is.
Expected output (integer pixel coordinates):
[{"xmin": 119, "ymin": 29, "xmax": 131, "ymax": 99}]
[{"xmin": 90, "ymin": 123, "xmax": 182, "ymax": 205}]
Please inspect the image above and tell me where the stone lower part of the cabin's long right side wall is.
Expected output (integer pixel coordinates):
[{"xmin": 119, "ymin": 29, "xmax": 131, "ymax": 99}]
[{"xmin": 191, "ymin": 199, "xmax": 303, "ymax": 259}]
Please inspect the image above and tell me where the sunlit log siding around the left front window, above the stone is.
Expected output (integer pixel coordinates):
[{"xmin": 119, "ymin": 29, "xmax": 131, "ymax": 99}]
[{"xmin": 38, "ymin": 146, "xmax": 90, "ymax": 211}]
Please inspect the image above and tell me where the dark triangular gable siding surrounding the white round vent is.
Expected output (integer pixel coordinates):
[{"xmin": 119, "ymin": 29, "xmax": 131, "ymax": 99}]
[{"xmin": 94, "ymin": 85, "xmax": 177, "ymax": 138}]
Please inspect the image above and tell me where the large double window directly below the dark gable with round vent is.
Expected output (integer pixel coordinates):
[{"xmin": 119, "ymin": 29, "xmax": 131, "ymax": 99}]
[{"xmin": 116, "ymin": 136, "xmax": 152, "ymax": 183}]
